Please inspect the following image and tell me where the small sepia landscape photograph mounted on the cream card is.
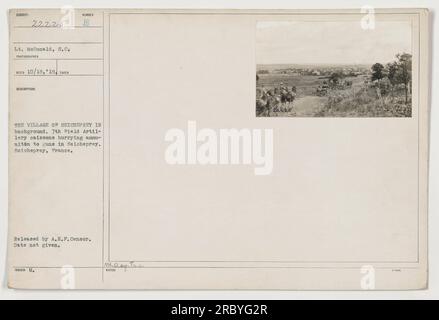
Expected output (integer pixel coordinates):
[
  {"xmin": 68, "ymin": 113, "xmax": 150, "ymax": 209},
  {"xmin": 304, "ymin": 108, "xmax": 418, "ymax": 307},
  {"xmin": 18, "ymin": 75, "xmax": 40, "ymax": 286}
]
[{"xmin": 256, "ymin": 19, "xmax": 412, "ymax": 117}]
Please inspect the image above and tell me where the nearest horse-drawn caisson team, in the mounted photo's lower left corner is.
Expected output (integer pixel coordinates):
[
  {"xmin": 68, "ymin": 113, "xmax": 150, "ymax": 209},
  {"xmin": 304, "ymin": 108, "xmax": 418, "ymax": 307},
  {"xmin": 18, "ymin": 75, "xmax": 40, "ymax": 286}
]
[{"xmin": 256, "ymin": 83, "xmax": 296, "ymax": 117}]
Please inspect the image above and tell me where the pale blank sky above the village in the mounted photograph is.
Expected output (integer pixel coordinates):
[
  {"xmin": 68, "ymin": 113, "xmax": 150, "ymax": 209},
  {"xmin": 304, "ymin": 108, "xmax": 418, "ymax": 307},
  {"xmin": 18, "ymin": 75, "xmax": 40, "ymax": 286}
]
[{"xmin": 256, "ymin": 21, "xmax": 412, "ymax": 64}]
